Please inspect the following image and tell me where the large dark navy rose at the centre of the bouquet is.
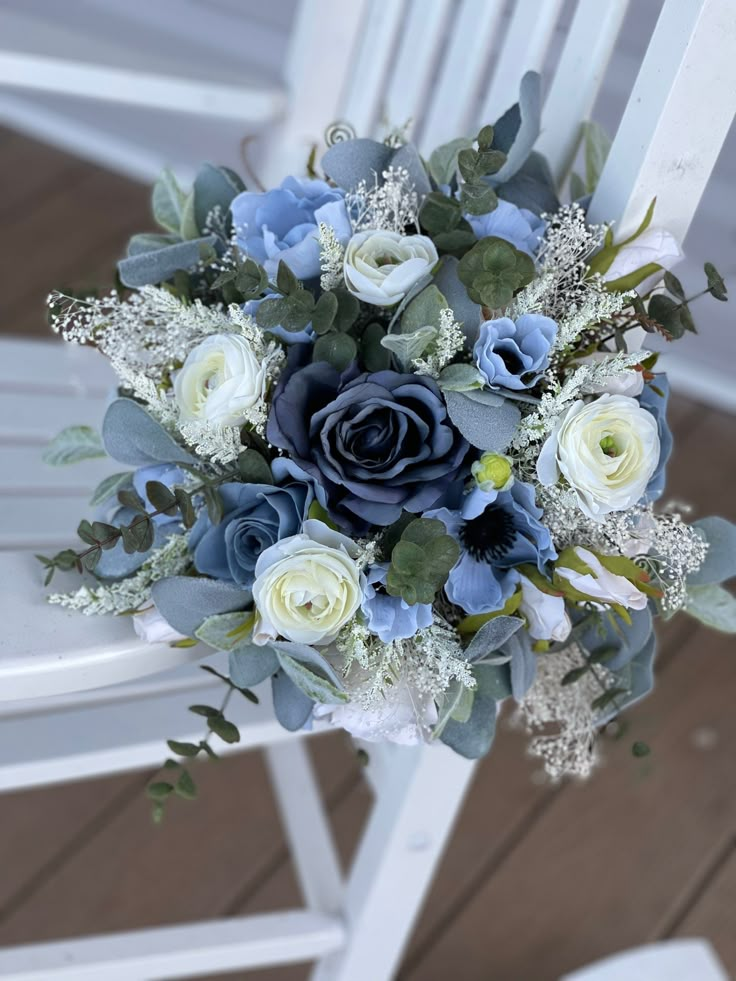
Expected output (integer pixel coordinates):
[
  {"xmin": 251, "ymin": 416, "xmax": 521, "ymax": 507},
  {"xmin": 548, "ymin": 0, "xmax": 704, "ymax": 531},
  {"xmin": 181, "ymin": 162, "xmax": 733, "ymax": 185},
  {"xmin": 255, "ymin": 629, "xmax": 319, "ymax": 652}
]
[{"xmin": 268, "ymin": 362, "xmax": 468, "ymax": 532}]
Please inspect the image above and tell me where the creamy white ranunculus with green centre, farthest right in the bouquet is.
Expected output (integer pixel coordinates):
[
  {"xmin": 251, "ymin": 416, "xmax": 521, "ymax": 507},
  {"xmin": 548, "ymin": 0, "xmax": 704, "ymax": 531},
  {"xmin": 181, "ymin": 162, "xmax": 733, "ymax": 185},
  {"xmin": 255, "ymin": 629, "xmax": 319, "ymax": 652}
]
[{"xmin": 537, "ymin": 395, "xmax": 660, "ymax": 521}]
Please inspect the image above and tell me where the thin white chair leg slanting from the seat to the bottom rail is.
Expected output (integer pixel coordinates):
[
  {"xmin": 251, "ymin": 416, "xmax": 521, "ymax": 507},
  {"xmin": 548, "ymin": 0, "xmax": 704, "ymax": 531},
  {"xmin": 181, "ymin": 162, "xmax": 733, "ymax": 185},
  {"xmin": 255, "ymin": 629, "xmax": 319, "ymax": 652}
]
[{"xmin": 265, "ymin": 739, "xmax": 343, "ymax": 914}]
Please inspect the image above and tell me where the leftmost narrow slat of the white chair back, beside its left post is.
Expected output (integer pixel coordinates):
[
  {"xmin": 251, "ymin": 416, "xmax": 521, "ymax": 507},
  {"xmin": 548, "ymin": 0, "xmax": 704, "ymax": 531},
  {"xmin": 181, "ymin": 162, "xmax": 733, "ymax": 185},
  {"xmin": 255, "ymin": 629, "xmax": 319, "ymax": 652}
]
[{"xmin": 339, "ymin": 0, "xmax": 406, "ymax": 136}]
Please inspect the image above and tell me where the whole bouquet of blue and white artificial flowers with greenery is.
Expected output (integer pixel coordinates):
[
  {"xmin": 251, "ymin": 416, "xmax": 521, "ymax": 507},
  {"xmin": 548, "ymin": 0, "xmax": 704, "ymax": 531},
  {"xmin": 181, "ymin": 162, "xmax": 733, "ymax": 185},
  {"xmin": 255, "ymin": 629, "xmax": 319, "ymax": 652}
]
[{"xmin": 42, "ymin": 74, "xmax": 736, "ymax": 814}]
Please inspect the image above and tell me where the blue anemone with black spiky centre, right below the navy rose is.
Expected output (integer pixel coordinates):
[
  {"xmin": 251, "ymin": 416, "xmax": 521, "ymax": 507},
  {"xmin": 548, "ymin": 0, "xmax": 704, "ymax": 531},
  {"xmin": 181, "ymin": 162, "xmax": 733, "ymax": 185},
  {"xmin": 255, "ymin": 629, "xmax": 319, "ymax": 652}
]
[{"xmin": 425, "ymin": 480, "xmax": 557, "ymax": 613}]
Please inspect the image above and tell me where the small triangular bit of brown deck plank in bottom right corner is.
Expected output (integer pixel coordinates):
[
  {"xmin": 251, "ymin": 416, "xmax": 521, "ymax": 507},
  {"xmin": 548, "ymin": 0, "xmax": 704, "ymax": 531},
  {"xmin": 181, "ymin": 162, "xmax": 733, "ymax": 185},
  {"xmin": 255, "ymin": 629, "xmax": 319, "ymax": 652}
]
[{"xmin": 674, "ymin": 839, "xmax": 736, "ymax": 976}]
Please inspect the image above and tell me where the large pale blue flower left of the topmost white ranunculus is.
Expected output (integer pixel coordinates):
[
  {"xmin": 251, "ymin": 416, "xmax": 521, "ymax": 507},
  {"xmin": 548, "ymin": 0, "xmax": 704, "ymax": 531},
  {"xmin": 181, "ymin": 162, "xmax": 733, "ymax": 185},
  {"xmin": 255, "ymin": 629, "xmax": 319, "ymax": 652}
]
[{"xmin": 230, "ymin": 177, "xmax": 351, "ymax": 279}]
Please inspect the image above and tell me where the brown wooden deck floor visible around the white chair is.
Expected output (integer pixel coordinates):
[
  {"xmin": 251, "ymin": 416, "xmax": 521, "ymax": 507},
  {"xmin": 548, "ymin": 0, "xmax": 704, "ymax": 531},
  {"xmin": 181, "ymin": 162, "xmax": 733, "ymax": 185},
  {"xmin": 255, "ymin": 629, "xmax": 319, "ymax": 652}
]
[{"xmin": 0, "ymin": 131, "xmax": 736, "ymax": 981}]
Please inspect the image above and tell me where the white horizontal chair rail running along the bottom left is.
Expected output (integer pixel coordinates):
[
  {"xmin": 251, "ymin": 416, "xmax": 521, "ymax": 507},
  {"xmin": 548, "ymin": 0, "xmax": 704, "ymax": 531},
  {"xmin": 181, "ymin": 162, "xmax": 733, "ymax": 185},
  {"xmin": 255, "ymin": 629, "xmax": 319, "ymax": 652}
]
[{"xmin": 0, "ymin": 910, "xmax": 344, "ymax": 981}]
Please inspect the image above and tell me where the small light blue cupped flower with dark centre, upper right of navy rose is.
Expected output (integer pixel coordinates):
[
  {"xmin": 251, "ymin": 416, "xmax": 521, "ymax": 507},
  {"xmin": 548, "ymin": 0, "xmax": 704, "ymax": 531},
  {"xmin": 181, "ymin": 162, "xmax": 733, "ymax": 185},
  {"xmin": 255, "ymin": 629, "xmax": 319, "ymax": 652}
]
[{"xmin": 473, "ymin": 313, "xmax": 557, "ymax": 392}]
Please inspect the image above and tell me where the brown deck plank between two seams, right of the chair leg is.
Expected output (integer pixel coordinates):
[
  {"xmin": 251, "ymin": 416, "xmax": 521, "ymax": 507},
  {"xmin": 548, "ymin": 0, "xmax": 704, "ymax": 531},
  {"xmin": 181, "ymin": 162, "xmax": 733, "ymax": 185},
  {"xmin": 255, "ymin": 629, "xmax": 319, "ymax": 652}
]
[{"xmin": 403, "ymin": 630, "xmax": 736, "ymax": 981}]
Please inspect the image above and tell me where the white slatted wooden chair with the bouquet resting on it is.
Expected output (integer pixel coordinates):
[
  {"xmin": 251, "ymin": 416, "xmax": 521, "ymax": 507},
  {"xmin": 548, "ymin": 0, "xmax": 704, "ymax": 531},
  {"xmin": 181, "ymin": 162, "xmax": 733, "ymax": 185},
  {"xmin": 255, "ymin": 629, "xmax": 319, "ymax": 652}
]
[{"xmin": 0, "ymin": 0, "xmax": 736, "ymax": 981}]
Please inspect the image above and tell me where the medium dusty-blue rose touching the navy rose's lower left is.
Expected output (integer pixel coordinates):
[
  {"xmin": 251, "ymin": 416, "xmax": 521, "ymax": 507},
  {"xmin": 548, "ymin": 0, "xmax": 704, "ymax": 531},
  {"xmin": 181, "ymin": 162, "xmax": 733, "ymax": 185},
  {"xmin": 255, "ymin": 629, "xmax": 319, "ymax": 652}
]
[{"xmin": 189, "ymin": 459, "xmax": 314, "ymax": 589}]
